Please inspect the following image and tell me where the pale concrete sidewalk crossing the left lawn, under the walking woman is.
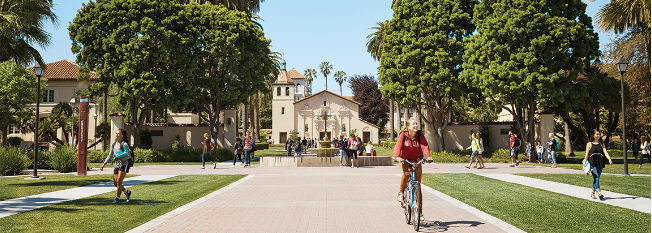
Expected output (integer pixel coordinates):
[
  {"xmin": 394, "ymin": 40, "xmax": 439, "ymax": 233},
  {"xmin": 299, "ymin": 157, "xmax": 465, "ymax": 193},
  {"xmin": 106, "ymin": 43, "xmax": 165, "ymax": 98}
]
[{"xmin": 0, "ymin": 175, "xmax": 176, "ymax": 218}]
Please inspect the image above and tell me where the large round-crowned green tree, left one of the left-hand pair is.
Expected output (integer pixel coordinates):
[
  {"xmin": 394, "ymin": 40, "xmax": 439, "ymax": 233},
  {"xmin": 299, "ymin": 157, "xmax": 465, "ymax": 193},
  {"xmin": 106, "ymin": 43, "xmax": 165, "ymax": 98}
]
[{"xmin": 68, "ymin": 0, "xmax": 201, "ymax": 147}]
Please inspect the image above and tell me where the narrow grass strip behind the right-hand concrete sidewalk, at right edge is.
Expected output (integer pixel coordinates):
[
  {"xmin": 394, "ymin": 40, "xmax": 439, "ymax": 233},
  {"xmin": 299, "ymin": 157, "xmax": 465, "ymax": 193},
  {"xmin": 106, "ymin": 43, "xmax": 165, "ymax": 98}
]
[{"xmin": 515, "ymin": 173, "xmax": 651, "ymax": 198}]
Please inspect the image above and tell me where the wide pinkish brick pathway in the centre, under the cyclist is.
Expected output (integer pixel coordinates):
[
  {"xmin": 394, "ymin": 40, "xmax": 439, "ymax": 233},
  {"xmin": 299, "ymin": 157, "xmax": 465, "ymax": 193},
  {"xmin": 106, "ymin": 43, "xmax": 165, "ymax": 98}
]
[{"xmin": 117, "ymin": 165, "xmax": 550, "ymax": 232}]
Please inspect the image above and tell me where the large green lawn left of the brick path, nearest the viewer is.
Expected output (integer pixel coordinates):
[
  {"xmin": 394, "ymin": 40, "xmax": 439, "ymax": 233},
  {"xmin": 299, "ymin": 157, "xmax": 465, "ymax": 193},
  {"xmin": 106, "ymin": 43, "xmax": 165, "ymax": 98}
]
[{"xmin": 0, "ymin": 175, "xmax": 245, "ymax": 232}]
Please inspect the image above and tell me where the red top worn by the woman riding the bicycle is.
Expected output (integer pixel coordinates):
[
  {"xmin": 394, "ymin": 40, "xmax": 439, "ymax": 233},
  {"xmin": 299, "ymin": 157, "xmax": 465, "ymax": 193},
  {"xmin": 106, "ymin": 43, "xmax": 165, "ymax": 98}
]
[{"xmin": 394, "ymin": 132, "xmax": 430, "ymax": 163}]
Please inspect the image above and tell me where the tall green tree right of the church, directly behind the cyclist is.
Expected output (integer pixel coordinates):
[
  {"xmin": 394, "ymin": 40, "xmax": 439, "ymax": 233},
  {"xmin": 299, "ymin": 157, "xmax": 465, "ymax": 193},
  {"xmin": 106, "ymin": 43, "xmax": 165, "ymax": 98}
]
[{"xmin": 380, "ymin": 0, "xmax": 477, "ymax": 151}]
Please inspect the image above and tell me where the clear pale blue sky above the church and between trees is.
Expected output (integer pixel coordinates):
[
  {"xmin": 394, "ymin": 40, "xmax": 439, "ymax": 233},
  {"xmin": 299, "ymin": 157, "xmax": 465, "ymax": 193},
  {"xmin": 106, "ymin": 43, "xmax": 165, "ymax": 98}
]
[{"xmin": 37, "ymin": 0, "xmax": 613, "ymax": 96}]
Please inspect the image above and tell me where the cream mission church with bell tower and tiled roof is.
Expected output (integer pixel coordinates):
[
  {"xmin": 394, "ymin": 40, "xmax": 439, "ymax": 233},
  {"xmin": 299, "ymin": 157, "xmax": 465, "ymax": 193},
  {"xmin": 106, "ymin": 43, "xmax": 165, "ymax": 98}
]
[{"xmin": 272, "ymin": 66, "xmax": 379, "ymax": 144}]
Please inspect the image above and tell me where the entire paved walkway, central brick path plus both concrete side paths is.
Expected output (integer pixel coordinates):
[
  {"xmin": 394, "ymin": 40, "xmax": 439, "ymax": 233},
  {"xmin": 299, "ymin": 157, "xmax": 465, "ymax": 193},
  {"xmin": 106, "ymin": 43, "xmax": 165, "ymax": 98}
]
[{"xmin": 0, "ymin": 163, "xmax": 650, "ymax": 232}]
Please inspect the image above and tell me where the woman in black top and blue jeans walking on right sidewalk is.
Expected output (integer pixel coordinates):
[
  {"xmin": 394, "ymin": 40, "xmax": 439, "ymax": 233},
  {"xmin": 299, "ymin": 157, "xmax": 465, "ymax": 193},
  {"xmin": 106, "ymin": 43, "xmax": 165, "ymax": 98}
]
[{"xmin": 584, "ymin": 129, "xmax": 613, "ymax": 200}]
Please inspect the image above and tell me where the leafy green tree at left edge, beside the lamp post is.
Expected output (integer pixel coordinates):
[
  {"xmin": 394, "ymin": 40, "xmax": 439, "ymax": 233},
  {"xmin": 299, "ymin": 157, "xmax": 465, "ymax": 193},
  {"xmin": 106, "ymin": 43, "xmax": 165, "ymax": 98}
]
[{"xmin": 0, "ymin": 61, "xmax": 48, "ymax": 146}]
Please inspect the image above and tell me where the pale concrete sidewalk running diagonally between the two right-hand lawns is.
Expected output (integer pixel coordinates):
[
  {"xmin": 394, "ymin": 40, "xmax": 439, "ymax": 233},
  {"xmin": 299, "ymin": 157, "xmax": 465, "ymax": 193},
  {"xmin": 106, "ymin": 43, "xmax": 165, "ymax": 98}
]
[{"xmin": 478, "ymin": 174, "xmax": 652, "ymax": 214}]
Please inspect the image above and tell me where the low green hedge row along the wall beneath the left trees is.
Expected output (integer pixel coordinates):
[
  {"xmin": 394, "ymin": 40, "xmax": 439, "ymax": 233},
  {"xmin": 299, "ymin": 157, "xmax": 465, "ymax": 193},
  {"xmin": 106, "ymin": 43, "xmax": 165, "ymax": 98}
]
[{"xmin": 87, "ymin": 147, "xmax": 234, "ymax": 163}]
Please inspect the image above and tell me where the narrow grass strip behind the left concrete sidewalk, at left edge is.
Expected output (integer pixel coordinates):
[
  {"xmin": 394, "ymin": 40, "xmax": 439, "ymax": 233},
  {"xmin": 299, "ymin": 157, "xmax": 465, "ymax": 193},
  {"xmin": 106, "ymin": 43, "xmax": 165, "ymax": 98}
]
[{"xmin": 0, "ymin": 175, "xmax": 137, "ymax": 201}]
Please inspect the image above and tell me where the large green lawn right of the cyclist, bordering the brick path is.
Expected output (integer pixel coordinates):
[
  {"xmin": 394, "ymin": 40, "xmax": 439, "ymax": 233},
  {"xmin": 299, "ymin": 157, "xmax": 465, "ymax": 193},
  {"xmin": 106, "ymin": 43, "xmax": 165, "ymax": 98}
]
[{"xmin": 422, "ymin": 173, "xmax": 650, "ymax": 233}]
